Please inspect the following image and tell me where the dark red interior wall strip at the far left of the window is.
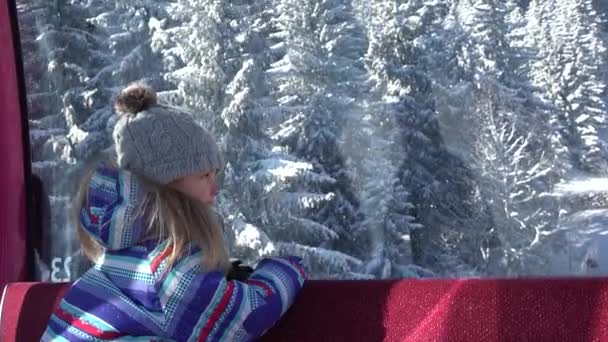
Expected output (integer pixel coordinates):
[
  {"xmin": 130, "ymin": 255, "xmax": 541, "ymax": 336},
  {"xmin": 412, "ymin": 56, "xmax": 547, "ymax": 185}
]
[{"xmin": 0, "ymin": 0, "xmax": 27, "ymax": 288}]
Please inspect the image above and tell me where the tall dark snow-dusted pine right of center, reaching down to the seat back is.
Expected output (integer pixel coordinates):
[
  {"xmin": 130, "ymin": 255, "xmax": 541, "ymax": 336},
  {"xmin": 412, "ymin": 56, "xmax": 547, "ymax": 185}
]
[{"xmin": 360, "ymin": 1, "xmax": 480, "ymax": 273}]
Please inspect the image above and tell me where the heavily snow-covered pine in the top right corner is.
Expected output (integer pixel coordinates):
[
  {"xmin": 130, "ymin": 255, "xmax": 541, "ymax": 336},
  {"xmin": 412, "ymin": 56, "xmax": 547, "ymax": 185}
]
[{"xmin": 528, "ymin": 0, "xmax": 606, "ymax": 175}]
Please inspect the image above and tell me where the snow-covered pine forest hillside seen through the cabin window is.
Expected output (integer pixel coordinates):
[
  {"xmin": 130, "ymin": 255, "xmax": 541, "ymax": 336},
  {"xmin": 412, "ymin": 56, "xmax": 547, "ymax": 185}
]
[{"xmin": 17, "ymin": 0, "xmax": 608, "ymax": 280}]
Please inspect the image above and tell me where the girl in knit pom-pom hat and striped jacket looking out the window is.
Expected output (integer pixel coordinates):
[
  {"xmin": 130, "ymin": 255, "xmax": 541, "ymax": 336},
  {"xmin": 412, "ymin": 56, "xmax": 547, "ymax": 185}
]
[{"xmin": 42, "ymin": 84, "xmax": 305, "ymax": 341}]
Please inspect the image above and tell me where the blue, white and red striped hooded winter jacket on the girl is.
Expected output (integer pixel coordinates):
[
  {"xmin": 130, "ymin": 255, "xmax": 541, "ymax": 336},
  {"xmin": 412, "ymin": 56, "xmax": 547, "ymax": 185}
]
[{"xmin": 42, "ymin": 167, "xmax": 305, "ymax": 341}]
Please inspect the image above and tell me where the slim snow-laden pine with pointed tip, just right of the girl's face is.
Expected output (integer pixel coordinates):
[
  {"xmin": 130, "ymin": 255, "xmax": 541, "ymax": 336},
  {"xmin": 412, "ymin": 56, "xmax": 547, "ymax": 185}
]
[{"xmin": 219, "ymin": 59, "xmax": 276, "ymax": 263}]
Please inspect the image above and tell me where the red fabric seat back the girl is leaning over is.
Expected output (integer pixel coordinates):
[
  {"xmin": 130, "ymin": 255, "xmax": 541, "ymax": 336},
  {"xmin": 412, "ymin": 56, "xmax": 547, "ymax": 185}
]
[{"xmin": 0, "ymin": 279, "xmax": 608, "ymax": 342}]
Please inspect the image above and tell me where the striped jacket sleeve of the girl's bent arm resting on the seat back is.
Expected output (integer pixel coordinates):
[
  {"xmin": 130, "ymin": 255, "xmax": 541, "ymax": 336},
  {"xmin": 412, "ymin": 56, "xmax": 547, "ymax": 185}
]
[{"xmin": 159, "ymin": 257, "xmax": 306, "ymax": 341}]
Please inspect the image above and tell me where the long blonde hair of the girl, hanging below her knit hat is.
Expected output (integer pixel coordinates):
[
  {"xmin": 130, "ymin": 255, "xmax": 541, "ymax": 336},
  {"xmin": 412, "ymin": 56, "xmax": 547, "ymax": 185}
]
[{"xmin": 72, "ymin": 159, "xmax": 230, "ymax": 273}]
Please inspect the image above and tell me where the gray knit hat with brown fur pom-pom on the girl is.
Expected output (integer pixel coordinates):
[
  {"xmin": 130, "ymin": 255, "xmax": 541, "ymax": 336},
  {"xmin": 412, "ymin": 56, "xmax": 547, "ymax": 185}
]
[{"xmin": 113, "ymin": 83, "xmax": 223, "ymax": 184}]
